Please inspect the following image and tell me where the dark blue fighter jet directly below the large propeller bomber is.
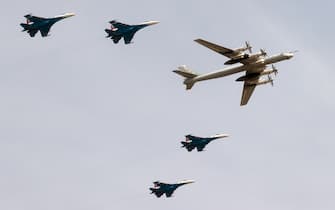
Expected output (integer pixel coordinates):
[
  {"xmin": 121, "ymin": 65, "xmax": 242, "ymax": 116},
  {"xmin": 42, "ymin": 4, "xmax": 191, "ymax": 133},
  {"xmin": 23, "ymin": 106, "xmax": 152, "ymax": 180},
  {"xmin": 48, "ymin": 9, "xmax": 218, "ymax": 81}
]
[{"xmin": 181, "ymin": 134, "xmax": 229, "ymax": 152}]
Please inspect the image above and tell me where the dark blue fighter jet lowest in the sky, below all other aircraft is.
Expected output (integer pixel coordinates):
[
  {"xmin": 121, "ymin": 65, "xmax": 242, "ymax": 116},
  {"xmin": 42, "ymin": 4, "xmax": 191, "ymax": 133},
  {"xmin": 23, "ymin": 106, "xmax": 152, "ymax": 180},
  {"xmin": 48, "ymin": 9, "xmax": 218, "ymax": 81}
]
[{"xmin": 149, "ymin": 180, "xmax": 194, "ymax": 198}]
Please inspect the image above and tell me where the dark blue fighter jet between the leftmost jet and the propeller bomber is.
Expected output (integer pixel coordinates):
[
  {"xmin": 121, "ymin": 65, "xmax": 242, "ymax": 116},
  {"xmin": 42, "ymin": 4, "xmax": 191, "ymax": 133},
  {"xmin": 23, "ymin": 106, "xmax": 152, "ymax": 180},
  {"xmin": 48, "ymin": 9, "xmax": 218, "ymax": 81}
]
[{"xmin": 105, "ymin": 20, "xmax": 159, "ymax": 44}]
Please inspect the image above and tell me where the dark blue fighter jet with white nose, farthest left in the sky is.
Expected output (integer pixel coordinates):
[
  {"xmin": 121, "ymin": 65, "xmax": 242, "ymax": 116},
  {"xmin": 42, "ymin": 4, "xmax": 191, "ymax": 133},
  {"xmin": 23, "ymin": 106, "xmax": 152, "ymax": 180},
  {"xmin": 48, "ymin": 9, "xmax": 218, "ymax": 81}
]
[{"xmin": 20, "ymin": 13, "xmax": 74, "ymax": 37}]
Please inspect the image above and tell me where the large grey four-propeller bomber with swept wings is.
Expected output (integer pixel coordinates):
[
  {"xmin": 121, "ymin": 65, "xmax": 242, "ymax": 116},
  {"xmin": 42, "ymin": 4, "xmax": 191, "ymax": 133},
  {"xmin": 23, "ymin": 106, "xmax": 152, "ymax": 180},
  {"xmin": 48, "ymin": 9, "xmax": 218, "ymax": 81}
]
[{"xmin": 173, "ymin": 39, "xmax": 294, "ymax": 106}]
